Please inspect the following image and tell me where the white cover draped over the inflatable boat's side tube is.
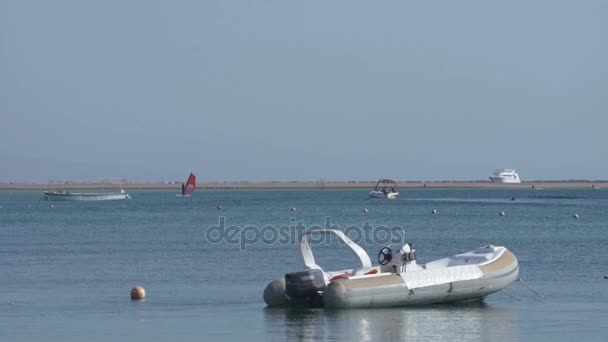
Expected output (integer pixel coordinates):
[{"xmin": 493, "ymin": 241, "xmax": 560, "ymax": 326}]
[{"xmin": 401, "ymin": 265, "xmax": 483, "ymax": 289}]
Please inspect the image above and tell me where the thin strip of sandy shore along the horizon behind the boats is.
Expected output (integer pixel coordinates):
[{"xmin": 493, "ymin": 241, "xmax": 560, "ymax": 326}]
[{"xmin": 0, "ymin": 181, "xmax": 608, "ymax": 190}]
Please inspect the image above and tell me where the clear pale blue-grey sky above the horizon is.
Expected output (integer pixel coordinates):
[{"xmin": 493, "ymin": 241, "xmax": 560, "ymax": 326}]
[{"xmin": 0, "ymin": 0, "xmax": 608, "ymax": 182}]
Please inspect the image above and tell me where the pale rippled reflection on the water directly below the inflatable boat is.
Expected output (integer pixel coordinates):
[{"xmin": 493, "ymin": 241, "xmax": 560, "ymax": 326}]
[{"xmin": 264, "ymin": 304, "xmax": 519, "ymax": 341}]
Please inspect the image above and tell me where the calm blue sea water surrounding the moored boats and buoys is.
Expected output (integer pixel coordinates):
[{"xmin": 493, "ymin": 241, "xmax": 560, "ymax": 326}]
[{"xmin": 0, "ymin": 189, "xmax": 608, "ymax": 341}]
